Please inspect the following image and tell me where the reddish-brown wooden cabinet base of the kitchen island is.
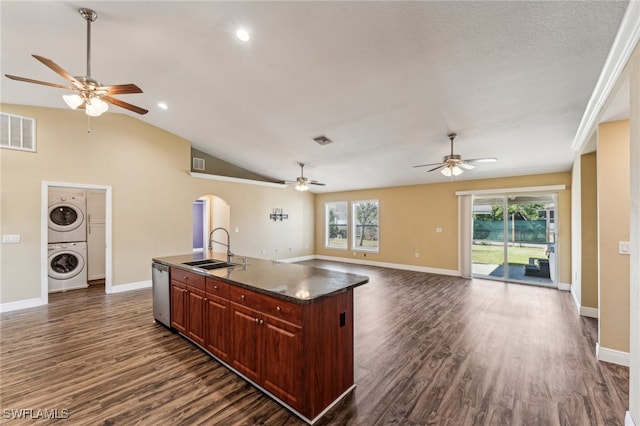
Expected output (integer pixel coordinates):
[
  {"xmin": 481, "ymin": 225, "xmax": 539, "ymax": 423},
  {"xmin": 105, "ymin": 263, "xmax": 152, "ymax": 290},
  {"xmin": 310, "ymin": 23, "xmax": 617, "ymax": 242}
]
[{"xmin": 171, "ymin": 268, "xmax": 354, "ymax": 421}]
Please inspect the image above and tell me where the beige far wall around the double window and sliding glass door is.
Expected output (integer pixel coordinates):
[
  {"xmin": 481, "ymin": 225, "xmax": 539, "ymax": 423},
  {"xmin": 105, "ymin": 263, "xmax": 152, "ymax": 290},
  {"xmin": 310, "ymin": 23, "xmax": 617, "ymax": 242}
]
[{"xmin": 315, "ymin": 172, "xmax": 571, "ymax": 283}]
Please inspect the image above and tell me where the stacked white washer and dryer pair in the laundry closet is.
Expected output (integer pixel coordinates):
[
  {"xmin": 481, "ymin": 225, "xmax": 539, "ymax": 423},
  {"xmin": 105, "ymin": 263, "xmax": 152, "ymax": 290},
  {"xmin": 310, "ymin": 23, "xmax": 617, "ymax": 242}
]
[{"xmin": 48, "ymin": 187, "xmax": 88, "ymax": 293}]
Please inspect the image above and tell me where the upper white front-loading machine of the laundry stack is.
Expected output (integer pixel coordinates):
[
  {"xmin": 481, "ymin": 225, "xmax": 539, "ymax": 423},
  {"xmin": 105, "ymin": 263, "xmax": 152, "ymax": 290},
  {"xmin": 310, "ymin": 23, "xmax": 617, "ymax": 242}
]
[{"xmin": 48, "ymin": 187, "xmax": 87, "ymax": 243}]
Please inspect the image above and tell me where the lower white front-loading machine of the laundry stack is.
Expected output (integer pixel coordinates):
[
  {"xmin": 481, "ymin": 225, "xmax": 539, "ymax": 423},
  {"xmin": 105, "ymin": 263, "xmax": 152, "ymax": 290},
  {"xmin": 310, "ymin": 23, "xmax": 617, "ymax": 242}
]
[{"xmin": 47, "ymin": 241, "xmax": 89, "ymax": 293}]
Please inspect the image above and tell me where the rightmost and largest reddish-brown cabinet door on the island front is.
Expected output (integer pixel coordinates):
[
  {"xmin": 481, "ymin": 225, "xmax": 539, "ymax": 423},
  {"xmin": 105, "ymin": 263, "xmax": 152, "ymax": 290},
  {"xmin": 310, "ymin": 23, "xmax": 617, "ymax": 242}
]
[{"xmin": 260, "ymin": 315, "xmax": 302, "ymax": 408}]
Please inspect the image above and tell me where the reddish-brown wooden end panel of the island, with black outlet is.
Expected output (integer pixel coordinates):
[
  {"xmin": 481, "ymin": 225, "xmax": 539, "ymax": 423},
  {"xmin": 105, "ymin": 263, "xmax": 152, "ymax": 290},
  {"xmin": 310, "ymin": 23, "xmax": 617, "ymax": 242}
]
[{"xmin": 303, "ymin": 289, "xmax": 354, "ymax": 419}]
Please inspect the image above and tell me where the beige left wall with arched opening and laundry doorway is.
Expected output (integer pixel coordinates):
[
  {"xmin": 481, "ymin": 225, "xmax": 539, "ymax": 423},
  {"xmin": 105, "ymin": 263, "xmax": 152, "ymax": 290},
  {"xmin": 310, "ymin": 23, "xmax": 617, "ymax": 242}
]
[{"xmin": 0, "ymin": 105, "xmax": 314, "ymax": 303}]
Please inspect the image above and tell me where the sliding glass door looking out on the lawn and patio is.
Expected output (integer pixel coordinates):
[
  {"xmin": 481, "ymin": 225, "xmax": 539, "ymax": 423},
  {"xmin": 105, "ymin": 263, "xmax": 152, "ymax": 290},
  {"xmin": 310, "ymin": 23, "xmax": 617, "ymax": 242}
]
[{"xmin": 471, "ymin": 193, "xmax": 557, "ymax": 286}]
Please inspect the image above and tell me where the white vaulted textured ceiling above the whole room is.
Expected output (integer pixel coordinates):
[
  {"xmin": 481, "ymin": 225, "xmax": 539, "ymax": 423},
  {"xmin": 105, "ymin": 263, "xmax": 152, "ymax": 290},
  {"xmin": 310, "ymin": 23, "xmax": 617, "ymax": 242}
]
[{"xmin": 0, "ymin": 1, "xmax": 627, "ymax": 192}]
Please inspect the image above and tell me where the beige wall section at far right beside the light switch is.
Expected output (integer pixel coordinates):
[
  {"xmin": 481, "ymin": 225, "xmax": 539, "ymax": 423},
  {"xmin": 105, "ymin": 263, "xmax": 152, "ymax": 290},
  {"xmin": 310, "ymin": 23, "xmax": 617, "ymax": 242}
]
[{"xmin": 597, "ymin": 121, "xmax": 630, "ymax": 352}]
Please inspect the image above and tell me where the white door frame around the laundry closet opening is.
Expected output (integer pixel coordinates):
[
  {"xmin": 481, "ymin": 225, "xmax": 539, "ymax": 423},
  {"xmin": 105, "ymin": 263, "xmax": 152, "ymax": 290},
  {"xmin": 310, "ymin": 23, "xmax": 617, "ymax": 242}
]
[{"xmin": 40, "ymin": 181, "xmax": 113, "ymax": 305}]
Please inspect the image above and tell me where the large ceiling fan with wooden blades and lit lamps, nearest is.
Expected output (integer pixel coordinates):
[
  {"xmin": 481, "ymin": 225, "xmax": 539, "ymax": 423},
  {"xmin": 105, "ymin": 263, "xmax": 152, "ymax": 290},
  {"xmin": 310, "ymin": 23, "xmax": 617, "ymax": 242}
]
[{"xmin": 5, "ymin": 8, "xmax": 149, "ymax": 117}]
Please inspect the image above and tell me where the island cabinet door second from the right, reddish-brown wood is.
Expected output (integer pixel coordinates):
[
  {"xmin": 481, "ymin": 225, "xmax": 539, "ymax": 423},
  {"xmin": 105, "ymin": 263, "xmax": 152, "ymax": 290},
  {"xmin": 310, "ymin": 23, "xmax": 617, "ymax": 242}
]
[{"xmin": 230, "ymin": 303, "xmax": 261, "ymax": 383}]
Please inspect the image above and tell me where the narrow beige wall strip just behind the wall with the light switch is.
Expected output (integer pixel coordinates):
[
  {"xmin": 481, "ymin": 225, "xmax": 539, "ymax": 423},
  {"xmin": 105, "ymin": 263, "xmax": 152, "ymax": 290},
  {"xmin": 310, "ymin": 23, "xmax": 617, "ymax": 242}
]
[{"xmin": 579, "ymin": 152, "xmax": 598, "ymax": 308}]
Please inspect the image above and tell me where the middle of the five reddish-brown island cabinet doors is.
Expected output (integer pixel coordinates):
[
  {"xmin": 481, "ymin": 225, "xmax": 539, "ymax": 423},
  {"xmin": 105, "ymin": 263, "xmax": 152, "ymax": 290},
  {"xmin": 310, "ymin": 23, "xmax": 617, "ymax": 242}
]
[{"xmin": 205, "ymin": 293, "xmax": 230, "ymax": 362}]
